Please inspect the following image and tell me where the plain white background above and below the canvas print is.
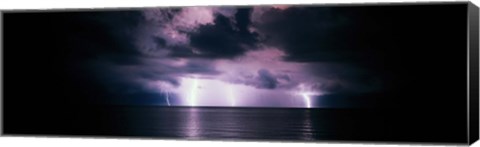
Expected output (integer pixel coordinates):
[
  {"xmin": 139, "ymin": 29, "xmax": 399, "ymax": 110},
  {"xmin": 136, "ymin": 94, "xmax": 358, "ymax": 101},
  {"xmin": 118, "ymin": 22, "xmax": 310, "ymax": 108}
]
[{"xmin": 0, "ymin": 0, "xmax": 480, "ymax": 147}]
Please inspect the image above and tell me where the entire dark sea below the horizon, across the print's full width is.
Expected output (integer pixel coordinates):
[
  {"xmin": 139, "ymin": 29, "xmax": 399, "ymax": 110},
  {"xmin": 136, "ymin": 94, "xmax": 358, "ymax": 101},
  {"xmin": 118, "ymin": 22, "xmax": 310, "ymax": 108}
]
[{"xmin": 4, "ymin": 105, "xmax": 467, "ymax": 143}]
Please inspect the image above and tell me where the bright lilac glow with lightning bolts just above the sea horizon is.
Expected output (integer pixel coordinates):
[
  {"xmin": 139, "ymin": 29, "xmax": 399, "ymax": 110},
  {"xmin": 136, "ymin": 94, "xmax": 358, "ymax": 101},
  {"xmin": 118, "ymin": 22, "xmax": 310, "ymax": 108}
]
[{"xmin": 156, "ymin": 77, "xmax": 321, "ymax": 108}]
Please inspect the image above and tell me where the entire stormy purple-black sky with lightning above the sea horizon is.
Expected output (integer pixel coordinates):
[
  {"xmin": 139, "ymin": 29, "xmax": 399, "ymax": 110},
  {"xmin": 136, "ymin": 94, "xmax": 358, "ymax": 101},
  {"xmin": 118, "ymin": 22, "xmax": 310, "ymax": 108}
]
[{"xmin": 4, "ymin": 5, "xmax": 466, "ymax": 107}]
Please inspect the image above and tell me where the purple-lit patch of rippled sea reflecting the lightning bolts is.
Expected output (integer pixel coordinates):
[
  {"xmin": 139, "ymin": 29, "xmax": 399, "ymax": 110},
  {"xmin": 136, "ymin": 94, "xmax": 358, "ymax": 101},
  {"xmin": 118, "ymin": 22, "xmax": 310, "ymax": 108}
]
[{"xmin": 176, "ymin": 107, "xmax": 315, "ymax": 140}]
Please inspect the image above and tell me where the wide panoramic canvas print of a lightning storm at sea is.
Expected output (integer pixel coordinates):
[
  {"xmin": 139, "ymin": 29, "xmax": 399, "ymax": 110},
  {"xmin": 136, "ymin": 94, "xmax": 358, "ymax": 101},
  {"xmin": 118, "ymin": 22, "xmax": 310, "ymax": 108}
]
[{"xmin": 2, "ymin": 2, "xmax": 478, "ymax": 144}]
